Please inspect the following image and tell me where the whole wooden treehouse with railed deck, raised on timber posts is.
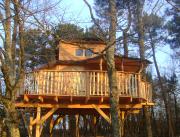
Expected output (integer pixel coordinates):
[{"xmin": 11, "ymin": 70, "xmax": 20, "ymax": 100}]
[{"xmin": 16, "ymin": 39, "xmax": 153, "ymax": 137}]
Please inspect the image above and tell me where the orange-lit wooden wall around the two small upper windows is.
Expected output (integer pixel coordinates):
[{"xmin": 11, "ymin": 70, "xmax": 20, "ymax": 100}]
[{"xmin": 58, "ymin": 42, "xmax": 105, "ymax": 61}]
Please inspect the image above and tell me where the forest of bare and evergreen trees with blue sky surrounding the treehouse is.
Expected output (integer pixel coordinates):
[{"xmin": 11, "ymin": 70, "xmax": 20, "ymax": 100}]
[{"xmin": 0, "ymin": 0, "xmax": 180, "ymax": 137}]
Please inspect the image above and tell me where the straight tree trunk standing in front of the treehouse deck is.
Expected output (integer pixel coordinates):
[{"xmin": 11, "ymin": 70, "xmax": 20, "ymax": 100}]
[{"xmin": 106, "ymin": 0, "xmax": 120, "ymax": 137}]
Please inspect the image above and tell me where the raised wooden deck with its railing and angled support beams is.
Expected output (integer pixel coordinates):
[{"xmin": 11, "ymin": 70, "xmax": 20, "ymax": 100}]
[{"xmin": 15, "ymin": 70, "xmax": 154, "ymax": 137}]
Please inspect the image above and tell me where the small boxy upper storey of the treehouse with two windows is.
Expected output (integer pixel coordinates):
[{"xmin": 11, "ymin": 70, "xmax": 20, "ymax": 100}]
[{"xmin": 58, "ymin": 40, "xmax": 105, "ymax": 61}]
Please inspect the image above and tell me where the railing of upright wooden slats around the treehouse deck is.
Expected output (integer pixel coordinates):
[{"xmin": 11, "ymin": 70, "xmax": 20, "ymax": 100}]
[{"xmin": 20, "ymin": 71, "xmax": 152, "ymax": 101}]
